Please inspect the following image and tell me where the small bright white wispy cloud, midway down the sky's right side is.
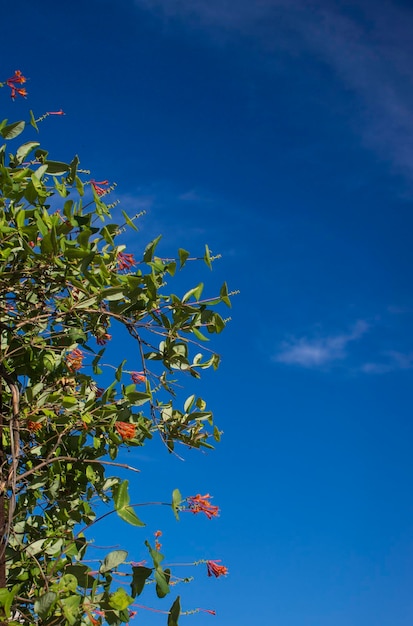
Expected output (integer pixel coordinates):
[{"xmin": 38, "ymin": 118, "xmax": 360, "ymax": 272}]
[{"xmin": 273, "ymin": 320, "xmax": 369, "ymax": 368}]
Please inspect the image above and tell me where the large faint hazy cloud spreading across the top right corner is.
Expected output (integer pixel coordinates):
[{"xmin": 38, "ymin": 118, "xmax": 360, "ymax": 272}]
[{"xmin": 135, "ymin": 0, "xmax": 413, "ymax": 178}]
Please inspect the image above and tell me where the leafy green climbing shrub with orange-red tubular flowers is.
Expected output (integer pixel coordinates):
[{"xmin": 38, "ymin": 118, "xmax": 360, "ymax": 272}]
[{"xmin": 0, "ymin": 71, "xmax": 231, "ymax": 626}]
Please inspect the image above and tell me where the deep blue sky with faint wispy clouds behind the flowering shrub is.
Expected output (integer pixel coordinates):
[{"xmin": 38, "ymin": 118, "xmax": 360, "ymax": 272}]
[{"xmin": 2, "ymin": 0, "xmax": 413, "ymax": 626}]
